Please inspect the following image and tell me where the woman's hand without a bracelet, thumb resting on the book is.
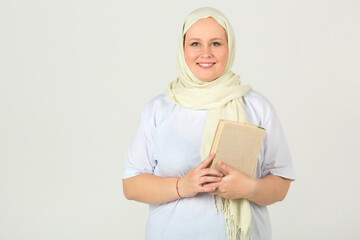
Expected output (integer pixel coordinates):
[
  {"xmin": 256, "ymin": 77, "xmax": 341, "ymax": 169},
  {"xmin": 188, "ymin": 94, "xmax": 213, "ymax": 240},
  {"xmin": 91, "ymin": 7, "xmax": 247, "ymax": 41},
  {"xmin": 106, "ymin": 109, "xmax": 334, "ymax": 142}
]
[{"xmin": 204, "ymin": 162, "xmax": 256, "ymax": 199}]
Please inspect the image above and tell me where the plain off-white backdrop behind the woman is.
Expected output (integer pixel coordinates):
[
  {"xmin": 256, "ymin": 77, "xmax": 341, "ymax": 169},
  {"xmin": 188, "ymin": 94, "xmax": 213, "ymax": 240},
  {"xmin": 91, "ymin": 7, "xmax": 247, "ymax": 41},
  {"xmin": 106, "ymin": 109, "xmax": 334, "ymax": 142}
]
[{"xmin": 0, "ymin": 0, "xmax": 360, "ymax": 240}]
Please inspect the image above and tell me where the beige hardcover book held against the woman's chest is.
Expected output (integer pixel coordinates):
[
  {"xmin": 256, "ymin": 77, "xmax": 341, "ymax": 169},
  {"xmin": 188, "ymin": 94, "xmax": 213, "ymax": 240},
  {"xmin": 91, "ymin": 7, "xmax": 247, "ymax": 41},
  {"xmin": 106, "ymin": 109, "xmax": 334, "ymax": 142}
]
[{"xmin": 210, "ymin": 119, "xmax": 266, "ymax": 177}]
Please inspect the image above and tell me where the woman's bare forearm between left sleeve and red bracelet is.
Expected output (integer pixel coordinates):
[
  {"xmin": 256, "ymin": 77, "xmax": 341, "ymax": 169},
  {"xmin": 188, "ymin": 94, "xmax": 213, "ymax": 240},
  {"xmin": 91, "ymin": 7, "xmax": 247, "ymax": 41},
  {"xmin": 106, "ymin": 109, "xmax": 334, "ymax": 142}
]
[{"xmin": 123, "ymin": 173, "xmax": 180, "ymax": 204}]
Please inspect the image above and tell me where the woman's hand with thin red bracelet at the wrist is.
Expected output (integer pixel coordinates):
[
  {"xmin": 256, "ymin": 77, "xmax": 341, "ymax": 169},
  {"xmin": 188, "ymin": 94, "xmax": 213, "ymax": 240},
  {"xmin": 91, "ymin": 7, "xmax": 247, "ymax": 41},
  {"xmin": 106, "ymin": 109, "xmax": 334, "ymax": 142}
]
[{"xmin": 178, "ymin": 154, "xmax": 223, "ymax": 197}]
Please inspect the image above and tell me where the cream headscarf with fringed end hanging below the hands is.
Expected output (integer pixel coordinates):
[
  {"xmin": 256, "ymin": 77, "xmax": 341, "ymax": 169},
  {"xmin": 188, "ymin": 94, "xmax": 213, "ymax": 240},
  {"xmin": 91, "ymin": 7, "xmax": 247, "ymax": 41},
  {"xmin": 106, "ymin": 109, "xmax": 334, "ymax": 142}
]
[{"xmin": 165, "ymin": 8, "xmax": 251, "ymax": 240}]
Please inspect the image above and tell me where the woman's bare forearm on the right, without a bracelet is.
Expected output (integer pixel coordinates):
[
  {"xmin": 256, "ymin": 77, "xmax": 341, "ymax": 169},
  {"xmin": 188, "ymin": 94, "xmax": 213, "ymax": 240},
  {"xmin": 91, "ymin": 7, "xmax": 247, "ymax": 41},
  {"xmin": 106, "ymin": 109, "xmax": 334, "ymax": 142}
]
[{"xmin": 248, "ymin": 175, "xmax": 290, "ymax": 206}]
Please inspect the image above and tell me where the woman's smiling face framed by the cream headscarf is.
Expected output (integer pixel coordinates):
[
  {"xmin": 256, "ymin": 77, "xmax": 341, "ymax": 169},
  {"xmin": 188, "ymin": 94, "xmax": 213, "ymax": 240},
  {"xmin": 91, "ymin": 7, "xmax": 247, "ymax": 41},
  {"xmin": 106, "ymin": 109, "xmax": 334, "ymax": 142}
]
[{"xmin": 184, "ymin": 18, "xmax": 229, "ymax": 82}]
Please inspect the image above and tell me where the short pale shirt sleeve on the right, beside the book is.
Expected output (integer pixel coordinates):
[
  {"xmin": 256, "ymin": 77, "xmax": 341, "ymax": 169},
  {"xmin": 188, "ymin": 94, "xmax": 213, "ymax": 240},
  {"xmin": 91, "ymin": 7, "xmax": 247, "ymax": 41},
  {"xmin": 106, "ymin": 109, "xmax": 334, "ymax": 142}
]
[{"xmin": 261, "ymin": 110, "xmax": 295, "ymax": 180}]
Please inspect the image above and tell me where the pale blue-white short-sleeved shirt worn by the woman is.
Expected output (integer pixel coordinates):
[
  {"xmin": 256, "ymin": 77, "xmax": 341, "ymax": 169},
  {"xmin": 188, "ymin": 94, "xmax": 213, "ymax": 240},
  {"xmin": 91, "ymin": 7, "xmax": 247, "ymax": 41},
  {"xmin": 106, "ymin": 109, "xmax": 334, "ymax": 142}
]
[{"xmin": 123, "ymin": 90, "xmax": 295, "ymax": 240}]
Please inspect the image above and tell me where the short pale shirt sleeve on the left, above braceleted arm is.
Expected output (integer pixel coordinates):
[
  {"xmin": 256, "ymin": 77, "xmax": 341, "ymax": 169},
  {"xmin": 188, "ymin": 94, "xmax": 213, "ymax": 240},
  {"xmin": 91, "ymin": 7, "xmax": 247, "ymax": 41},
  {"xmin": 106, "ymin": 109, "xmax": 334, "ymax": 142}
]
[{"xmin": 122, "ymin": 104, "xmax": 156, "ymax": 179}]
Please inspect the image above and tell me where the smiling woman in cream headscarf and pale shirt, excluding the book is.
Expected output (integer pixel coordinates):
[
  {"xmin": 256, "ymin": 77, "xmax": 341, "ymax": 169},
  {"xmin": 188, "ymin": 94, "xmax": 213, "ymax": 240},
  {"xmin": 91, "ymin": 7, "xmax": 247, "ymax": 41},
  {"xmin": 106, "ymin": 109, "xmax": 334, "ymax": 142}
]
[{"xmin": 123, "ymin": 8, "xmax": 294, "ymax": 240}]
